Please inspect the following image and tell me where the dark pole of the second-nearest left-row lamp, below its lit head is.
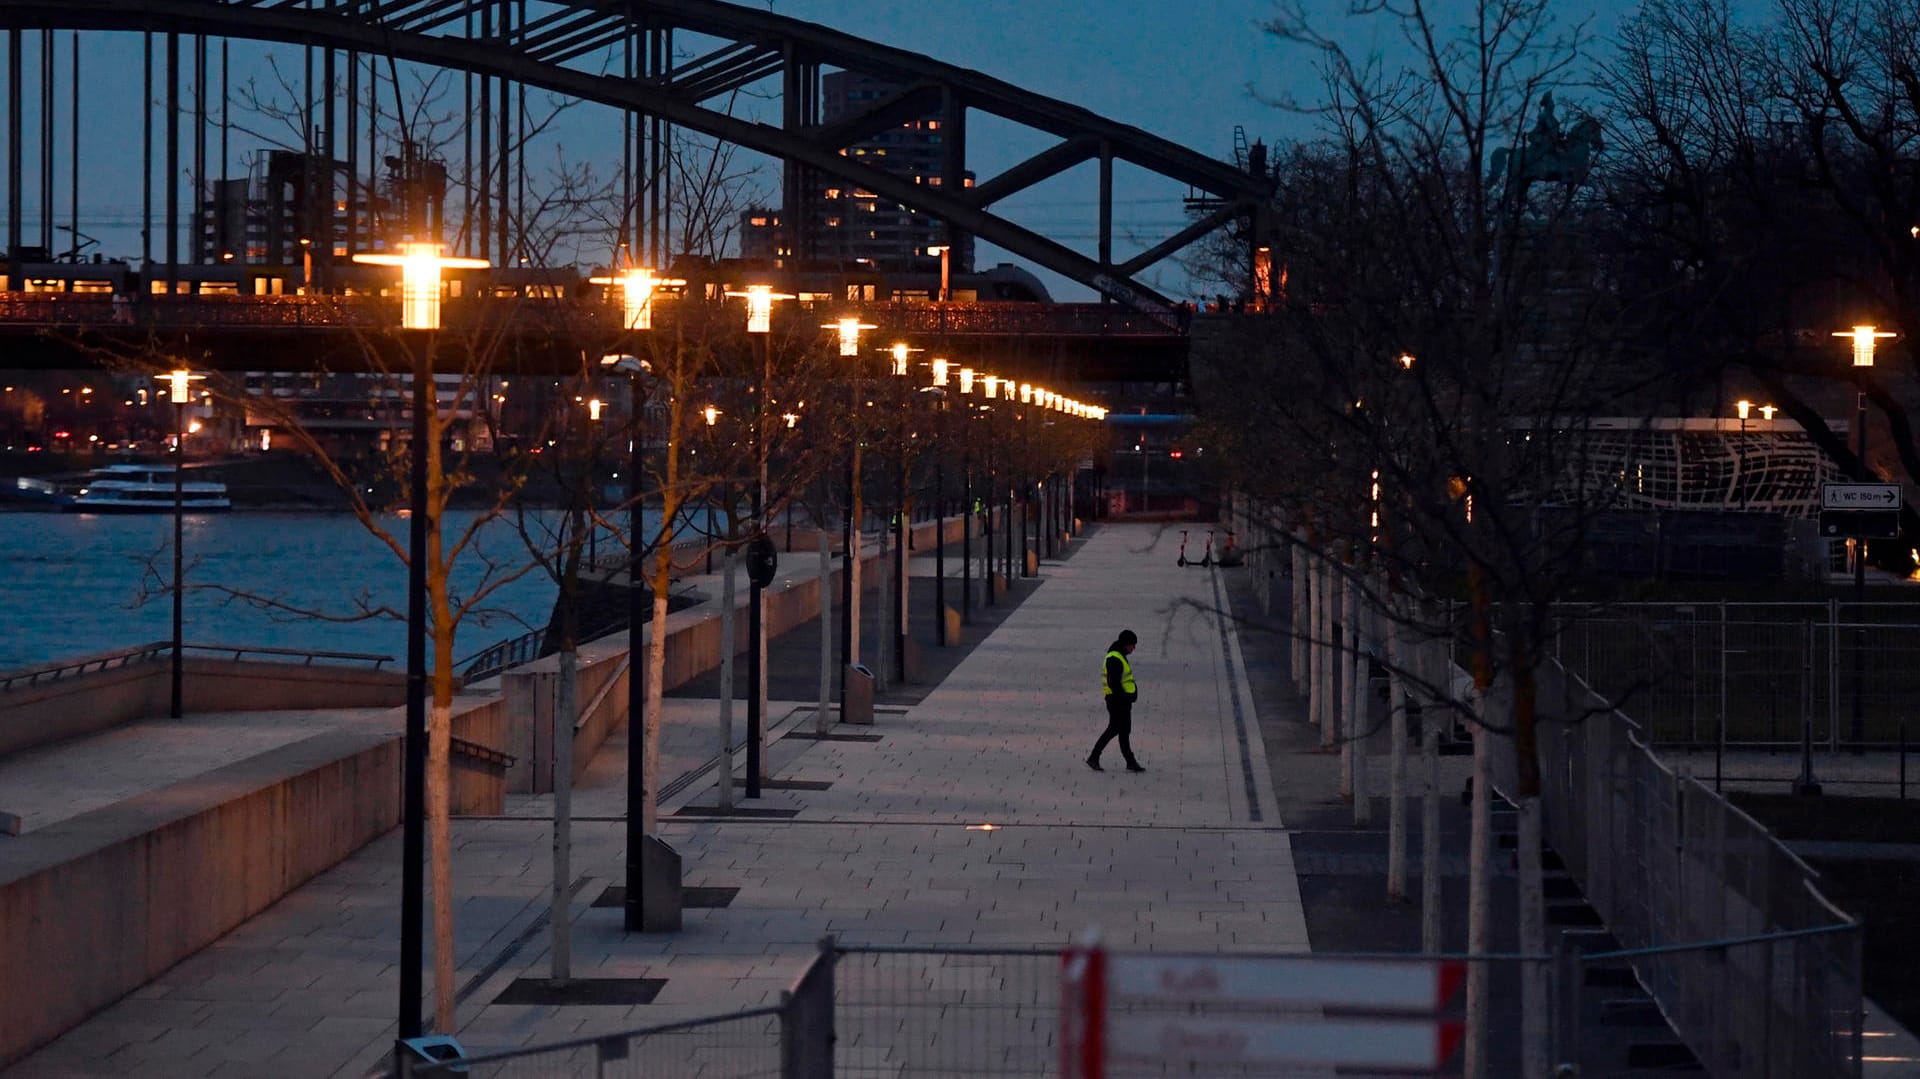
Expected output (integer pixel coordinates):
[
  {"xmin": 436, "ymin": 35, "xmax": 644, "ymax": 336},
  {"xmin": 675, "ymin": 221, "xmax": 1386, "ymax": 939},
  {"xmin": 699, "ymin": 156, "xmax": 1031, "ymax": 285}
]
[{"xmin": 601, "ymin": 355, "xmax": 651, "ymax": 933}]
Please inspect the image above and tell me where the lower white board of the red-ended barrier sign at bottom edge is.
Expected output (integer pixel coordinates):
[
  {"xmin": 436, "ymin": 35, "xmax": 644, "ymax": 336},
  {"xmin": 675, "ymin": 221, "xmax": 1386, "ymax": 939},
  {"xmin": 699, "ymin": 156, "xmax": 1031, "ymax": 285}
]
[{"xmin": 1106, "ymin": 1016, "xmax": 1463, "ymax": 1071}]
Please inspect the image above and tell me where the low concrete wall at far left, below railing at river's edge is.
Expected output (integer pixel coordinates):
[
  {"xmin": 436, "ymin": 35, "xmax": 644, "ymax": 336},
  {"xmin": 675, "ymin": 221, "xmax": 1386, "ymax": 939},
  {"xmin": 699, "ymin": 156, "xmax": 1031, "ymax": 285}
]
[{"xmin": 0, "ymin": 657, "xmax": 407, "ymax": 756}]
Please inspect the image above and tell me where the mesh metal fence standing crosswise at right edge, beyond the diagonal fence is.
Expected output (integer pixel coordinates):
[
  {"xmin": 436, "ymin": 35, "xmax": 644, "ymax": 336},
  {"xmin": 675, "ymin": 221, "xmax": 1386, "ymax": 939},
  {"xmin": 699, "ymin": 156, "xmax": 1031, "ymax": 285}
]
[{"xmin": 1555, "ymin": 603, "xmax": 1920, "ymax": 749}]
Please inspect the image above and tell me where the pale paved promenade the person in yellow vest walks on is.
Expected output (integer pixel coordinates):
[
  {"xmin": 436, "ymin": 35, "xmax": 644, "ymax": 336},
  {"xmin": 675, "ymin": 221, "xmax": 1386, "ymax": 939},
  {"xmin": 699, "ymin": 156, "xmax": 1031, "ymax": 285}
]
[{"xmin": 8, "ymin": 526, "xmax": 1308, "ymax": 1077}]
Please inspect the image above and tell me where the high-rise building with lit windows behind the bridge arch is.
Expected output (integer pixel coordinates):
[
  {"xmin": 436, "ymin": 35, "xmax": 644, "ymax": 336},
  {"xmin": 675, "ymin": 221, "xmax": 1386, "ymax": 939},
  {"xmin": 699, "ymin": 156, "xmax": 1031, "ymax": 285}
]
[{"xmin": 741, "ymin": 71, "xmax": 973, "ymax": 275}]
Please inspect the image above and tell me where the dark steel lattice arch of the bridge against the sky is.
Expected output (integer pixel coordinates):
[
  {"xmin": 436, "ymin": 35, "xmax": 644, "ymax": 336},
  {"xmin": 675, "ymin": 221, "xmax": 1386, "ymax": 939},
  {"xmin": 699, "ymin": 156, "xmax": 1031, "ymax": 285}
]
[{"xmin": 0, "ymin": 0, "xmax": 1271, "ymax": 319}]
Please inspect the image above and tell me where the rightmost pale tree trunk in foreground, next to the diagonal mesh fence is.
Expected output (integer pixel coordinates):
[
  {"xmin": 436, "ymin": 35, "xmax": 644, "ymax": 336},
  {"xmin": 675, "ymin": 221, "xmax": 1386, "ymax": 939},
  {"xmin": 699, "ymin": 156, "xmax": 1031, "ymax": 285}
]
[{"xmin": 1513, "ymin": 635, "xmax": 1551, "ymax": 1075}]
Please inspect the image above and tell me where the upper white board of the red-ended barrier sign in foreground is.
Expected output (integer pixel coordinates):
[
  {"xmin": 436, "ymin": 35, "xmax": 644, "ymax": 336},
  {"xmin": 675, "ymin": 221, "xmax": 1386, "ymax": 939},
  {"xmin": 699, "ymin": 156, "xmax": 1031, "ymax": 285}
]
[{"xmin": 1106, "ymin": 954, "xmax": 1467, "ymax": 1012}]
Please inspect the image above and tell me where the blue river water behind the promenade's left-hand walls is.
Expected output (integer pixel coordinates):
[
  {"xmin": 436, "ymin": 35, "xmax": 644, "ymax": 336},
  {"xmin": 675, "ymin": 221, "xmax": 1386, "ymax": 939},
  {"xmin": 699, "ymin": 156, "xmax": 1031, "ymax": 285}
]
[{"xmin": 0, "ymin": 511, "xmax": 660, "ymax": 670}]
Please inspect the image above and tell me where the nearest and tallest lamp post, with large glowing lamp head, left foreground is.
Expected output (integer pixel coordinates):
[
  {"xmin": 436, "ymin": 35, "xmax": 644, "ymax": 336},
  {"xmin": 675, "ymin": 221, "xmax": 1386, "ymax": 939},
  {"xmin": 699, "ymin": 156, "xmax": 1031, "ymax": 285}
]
[{"xmin": 353, "ymin": 244, "xmax": 488, "ymax": 1041}]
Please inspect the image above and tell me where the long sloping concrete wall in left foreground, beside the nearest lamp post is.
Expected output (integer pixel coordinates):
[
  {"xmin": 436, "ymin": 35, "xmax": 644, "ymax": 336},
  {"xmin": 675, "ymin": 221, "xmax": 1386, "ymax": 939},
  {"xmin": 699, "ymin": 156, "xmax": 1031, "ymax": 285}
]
[{"xmin": 0, "ymin": 701, "xmax": 505, "ymax": 1066}]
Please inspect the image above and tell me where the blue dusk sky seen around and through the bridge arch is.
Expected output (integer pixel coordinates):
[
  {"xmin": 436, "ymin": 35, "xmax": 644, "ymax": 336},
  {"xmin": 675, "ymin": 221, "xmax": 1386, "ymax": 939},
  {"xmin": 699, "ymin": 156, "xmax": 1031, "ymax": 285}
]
[{"xmin": 25, "ymin": 0, "xmax": 1635, "ymax": 300}]
